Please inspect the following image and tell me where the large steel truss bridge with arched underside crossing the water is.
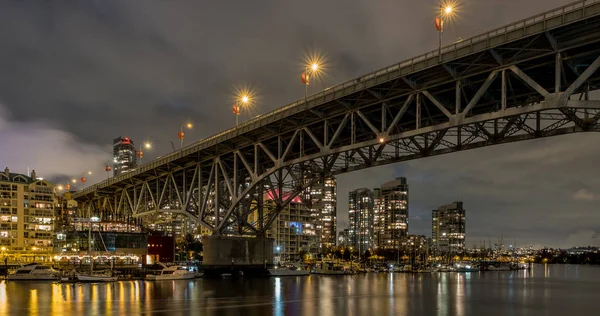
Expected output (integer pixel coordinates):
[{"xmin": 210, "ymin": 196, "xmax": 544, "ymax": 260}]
[{"xmin": 73, "ymin": 0, "xmax": 600, "ymax": 236}]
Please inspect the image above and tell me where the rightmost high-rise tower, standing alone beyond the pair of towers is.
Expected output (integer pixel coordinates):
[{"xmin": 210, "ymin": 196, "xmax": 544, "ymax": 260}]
[{"xmin": 431, "ymin": 202, "xmax": 466, "ymax": 254}]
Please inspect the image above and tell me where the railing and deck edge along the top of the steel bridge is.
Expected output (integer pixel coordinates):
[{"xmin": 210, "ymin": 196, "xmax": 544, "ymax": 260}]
[{"xmin": 76, "ymin": 0, "xmax": 600, "ymax": 195}]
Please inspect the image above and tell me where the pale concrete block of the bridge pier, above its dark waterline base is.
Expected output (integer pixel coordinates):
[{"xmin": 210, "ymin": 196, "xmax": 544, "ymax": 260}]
[{"xmin": 202, "ymin": 236, "xmax": 273, "ymax": 266}]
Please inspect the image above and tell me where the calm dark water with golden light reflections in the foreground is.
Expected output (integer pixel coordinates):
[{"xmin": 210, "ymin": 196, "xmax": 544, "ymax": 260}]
[{"xmin": 0, "ymin": 265, "xmax": 600, "ymax": 316}]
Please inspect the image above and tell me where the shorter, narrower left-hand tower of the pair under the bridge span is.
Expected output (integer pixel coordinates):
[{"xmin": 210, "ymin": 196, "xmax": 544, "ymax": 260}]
[{"xmin": 348, "ymin": 189, "xmax": 374, "ymax": 254}]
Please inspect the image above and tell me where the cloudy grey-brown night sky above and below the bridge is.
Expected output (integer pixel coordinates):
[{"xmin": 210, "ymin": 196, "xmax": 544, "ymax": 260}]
[{"xmin": 0, "ymin": 0, "xmax": 600, "ymax": 247}]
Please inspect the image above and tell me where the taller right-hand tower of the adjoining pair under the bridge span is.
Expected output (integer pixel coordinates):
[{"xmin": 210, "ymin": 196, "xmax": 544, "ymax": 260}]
[{"xmin": 373, "ymin": 177, "xmax": 408, "ymax": 249}]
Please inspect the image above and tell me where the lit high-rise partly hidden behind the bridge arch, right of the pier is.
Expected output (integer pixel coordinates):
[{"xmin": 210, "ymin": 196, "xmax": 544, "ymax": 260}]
[{"xmin": 304, "ymin": 177, "xmax": 337, "ymax": 252}]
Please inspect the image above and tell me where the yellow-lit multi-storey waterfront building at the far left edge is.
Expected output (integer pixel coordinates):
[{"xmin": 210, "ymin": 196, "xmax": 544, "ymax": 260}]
[{"xmin": 0, "ymin": 168, "xmax": 57, "ymax": 262}]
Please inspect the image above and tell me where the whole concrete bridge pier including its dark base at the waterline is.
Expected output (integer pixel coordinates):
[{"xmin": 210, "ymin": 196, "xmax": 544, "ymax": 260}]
[{"xmin": 202, "ymin": 236, "xmax": 274, "ymax": 278}]
